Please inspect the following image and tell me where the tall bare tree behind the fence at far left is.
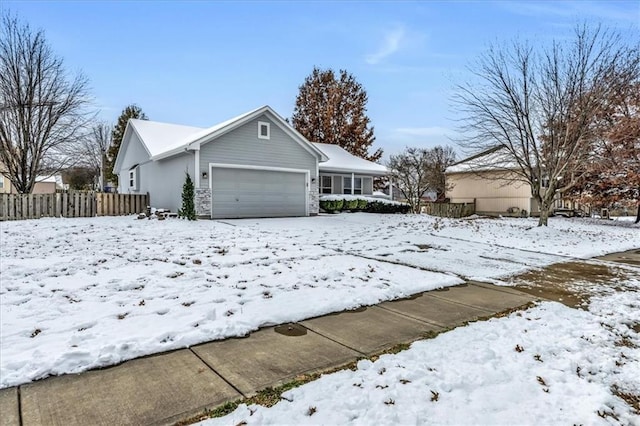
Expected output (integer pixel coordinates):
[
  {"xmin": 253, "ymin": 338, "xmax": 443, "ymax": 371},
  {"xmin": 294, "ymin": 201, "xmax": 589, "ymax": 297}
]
[{"xmin": 0, "ymin": 13, "xmax": 90, "ymax": 193}]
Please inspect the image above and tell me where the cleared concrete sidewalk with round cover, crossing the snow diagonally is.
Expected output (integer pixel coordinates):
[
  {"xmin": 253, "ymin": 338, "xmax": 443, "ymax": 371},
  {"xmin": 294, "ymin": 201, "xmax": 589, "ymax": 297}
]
[{"xmin": 0, "ymin": 283, "xmax": 536, "ymax": 425}]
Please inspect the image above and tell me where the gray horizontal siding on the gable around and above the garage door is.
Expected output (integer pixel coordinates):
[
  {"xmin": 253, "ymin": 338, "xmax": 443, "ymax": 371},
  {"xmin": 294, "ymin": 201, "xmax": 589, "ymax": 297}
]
[{"xmin": 199, "ymin": 114, "xmax": 317, "ymax": 188}]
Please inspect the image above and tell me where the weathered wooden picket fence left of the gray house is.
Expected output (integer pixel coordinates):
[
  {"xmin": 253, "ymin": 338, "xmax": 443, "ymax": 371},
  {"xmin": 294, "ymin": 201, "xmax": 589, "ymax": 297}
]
[{"xmin": 0, "ymin": 192, "xmax": 149, "ymax": 221}]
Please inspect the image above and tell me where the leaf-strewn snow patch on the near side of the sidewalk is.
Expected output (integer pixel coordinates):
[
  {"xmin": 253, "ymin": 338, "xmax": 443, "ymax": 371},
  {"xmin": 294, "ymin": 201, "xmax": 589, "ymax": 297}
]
[{"xmin": 202, "ymin": 282, "xmax": 640, "ymax": 426}]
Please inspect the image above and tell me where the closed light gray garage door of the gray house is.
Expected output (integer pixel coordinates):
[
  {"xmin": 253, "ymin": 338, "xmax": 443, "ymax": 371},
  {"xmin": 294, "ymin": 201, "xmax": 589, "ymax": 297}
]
[{"xmin": 211, "ymin": 167, "xmax": 307, "ymax": 219}]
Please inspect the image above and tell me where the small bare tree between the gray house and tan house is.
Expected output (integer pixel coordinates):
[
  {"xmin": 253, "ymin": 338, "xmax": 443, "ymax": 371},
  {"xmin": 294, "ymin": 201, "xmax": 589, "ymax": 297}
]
[{"xmin": 387, "ymin": 148, "xmax": 431, "ymax": 213}]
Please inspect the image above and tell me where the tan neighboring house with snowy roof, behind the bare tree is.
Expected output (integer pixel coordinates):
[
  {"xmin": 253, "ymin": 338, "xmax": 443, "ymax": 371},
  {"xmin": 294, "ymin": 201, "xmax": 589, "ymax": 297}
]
[{"xmin": 445, "ymin": 148, "xmax": 540, "ymax": 215}]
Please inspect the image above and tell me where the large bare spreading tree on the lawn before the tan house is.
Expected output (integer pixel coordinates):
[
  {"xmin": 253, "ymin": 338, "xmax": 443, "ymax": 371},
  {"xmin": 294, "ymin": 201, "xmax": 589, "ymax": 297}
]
[{"xmin": 455, "ymin": 25, "xmax": 639, "ymax": 226}]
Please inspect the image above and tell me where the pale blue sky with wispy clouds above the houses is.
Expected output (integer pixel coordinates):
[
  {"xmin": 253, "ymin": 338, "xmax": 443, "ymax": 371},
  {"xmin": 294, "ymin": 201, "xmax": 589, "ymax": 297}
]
[{"xmin": 0, "ymin": 0, "xmax": 640, "ymax": 158}]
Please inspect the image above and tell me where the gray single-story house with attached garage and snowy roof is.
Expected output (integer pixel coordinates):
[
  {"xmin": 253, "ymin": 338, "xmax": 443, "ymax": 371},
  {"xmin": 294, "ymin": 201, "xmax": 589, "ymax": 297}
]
[{"xmin": 114, "ymin": 106, "xmax": 387, "ymax": 218}]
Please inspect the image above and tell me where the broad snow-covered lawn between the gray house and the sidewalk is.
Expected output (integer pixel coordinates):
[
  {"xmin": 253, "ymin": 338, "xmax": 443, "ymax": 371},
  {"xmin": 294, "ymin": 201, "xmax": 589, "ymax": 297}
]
[{"xmin": 0, "ymin": 213, "xmax": 640, "ymax": 387}]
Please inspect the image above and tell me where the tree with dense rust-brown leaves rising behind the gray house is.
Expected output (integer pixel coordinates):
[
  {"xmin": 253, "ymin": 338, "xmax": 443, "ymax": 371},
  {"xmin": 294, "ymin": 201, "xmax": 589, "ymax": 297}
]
[{"xmin": 291, "ymin": 67, "xmax": 382, "ymax": 161}]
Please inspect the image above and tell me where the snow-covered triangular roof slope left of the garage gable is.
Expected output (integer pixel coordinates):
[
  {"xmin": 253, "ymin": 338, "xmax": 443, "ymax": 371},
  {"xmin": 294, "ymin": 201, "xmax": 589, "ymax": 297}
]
[{"xmin": 129, "ymin": 118, "xmax": 203, "ymax": 157}]
